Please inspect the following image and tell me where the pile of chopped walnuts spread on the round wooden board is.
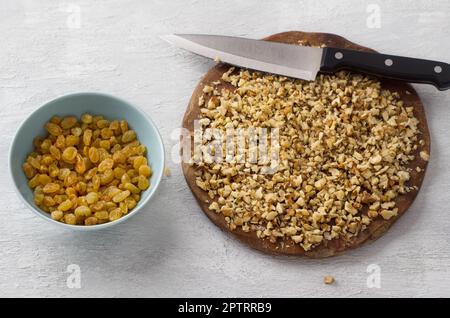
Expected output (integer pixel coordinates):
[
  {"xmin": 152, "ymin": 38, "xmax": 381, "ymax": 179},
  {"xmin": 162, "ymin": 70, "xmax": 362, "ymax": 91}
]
[{"xmin": 195, "ymin": 68, "xmax": 428, "ymax": 250}]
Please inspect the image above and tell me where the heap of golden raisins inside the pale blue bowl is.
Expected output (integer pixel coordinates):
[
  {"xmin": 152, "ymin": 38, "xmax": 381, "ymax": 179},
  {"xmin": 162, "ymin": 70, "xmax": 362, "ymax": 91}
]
[{"xmin": 22, "ymin": 114, "xmax": 151, "ymax": 225}]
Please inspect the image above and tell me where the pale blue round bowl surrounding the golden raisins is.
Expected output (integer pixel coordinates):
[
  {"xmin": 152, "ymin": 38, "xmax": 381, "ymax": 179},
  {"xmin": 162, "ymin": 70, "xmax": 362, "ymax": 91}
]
[{"xmin": 9, "ymin": 93, "xmax": 164, "ymax": 231}]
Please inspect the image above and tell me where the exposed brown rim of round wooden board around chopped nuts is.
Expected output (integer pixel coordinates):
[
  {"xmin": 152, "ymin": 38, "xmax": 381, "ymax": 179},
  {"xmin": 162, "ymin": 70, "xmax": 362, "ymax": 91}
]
[{"xmin": 182, "ymin": 31, "xmax": 430, "ymax": 258}]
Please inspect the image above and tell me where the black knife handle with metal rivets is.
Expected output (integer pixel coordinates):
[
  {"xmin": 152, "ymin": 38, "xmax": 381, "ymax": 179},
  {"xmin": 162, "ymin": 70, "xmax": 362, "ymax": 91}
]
[{"xmin": 320, "ymin": 47, "xmax": 450, "ymax": 90}]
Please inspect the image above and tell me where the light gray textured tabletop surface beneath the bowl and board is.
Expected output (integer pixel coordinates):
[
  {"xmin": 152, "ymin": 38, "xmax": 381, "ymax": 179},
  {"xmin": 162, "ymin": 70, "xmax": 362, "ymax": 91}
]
[{"xmin": 0, "ymin": 0, "xmax": 450, "ymax": 297}]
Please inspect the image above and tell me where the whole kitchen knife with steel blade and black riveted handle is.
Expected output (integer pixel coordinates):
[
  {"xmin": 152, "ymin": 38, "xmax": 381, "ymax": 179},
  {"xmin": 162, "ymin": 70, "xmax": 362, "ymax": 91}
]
[{"xmin": 162, "ymin": 34, "xmax": 450, "ymax": 90}]
